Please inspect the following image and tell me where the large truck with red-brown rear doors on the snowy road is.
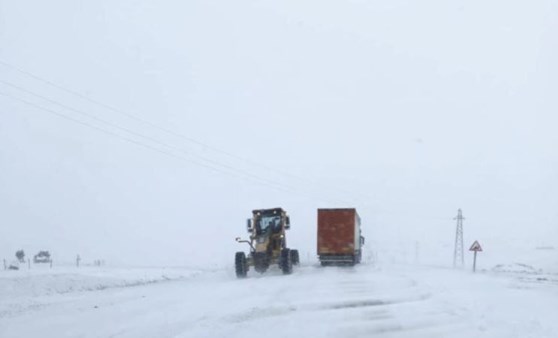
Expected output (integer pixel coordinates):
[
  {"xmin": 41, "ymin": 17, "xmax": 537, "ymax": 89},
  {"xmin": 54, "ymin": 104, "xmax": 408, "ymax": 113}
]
[{"xmin": 318, "ymin": 208, "xmax": 364, "ymax": 266}]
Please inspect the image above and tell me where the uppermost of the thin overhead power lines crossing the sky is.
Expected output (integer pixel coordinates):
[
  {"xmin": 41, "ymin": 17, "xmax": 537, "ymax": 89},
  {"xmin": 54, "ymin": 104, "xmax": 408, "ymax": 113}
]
[{"xmin": 0, "ymin": 60, "xmax": 368, "ymax": 203}]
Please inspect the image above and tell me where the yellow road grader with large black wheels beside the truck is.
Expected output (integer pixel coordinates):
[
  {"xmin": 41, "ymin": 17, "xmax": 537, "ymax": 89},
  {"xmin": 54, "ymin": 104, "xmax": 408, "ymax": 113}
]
[{"xmin": 234, "ymin": 208, "xmax": 299, "ymax": 278}]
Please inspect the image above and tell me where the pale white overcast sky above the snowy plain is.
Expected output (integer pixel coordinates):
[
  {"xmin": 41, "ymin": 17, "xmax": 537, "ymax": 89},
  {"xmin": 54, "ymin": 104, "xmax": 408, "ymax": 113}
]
[{"xmin": 0, "ymin": 0, "xmax": 558, "ymax": 264}]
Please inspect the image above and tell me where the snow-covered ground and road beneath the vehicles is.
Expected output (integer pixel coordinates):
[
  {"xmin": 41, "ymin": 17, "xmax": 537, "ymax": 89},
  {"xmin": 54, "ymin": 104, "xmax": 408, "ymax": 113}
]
[{"xmin": 0, "ymin": 265, "xmax": 558, "ymax": 338}]
